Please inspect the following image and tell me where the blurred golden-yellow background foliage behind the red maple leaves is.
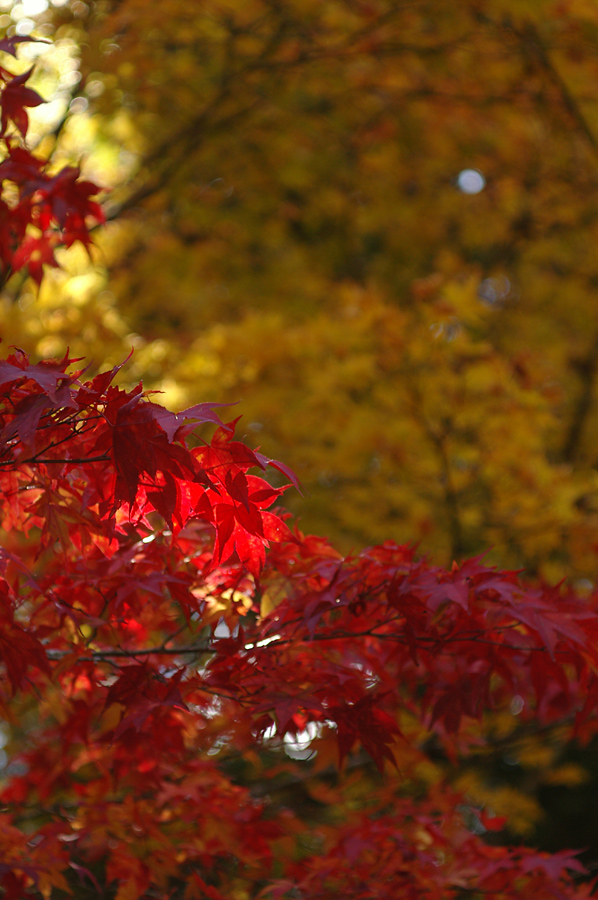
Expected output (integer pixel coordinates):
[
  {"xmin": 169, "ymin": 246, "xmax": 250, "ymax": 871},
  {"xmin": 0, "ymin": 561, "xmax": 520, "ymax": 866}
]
[{"xmin": 0, "ymin": 0, "xmax": 598, "ymax": 868}]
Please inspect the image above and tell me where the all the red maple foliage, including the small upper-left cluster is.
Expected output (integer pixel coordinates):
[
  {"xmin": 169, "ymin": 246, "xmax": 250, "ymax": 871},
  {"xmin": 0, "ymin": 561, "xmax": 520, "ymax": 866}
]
[{"xmin": 0, "ymin": 24, "xmax": 598, "ymax": 900}]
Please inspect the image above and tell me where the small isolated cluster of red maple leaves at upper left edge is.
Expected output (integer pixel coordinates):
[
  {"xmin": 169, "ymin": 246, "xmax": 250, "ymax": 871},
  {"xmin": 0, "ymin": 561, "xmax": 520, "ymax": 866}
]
[{"xmin": 0, "ymin": 37, "xmax": 104, "ymax": 284}]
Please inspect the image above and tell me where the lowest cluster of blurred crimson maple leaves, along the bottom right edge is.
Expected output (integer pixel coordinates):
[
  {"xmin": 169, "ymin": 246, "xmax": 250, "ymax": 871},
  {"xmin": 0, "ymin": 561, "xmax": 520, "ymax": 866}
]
[{"xmin": 260, "ymin": 794, "xmax": 589, "ymax": 900}]
